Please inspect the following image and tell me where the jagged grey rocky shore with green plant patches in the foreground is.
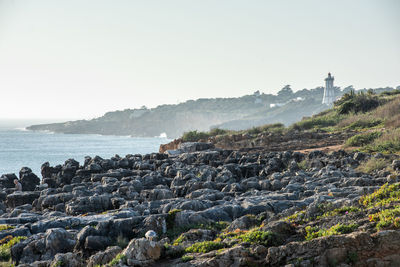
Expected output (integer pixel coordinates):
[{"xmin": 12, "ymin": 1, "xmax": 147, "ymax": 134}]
[{"xmin": 0, "ymin": 143, "xmax": 400, "ymax": 267}]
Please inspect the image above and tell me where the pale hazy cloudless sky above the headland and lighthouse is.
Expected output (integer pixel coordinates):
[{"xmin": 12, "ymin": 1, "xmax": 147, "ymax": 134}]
[{"xmin": 0, "ymin": 0, "xmax": 400, "ymax": 121}]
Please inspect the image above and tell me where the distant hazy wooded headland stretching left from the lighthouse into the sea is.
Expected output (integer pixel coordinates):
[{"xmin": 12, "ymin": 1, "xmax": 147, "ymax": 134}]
[{"xmin": 28, "ymin": 86, "xmax": 332, "ymax": 138}]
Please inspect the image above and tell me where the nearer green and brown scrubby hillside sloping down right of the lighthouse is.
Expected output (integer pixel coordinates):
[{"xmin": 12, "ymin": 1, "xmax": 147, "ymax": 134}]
[{"xmin": 160, "ymin": 90, "xmax": 400, "ymax": 153}]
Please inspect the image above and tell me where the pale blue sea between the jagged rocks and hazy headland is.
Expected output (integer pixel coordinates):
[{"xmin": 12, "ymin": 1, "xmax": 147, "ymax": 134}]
[{"xmin": 0, "ymin": 120, "xmax": 170, "ymax": 178}]
